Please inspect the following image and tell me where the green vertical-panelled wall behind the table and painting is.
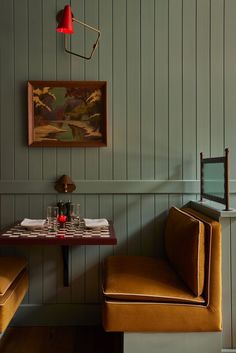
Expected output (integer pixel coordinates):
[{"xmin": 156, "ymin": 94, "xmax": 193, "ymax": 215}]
[{"xmin": 0, "ymin": 0, "xmax": 236, "ymax": 328}]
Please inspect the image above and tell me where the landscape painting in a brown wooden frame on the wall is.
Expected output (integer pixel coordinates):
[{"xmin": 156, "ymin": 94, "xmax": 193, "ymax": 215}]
[{"xmin": 28, "ymin": 81, "xmax": 107, "ymax": 147}]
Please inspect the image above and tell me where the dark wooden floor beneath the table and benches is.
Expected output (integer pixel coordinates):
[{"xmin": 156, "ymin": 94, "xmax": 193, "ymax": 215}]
[{"xmin": 0, "ymin": 326, "xmax": 122, "ymax": 353}]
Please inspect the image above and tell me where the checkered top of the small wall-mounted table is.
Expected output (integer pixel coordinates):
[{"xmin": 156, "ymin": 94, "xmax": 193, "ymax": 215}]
[{"xmin": 0, "ymin": 222, "xmax": 116, "ymax": 244}]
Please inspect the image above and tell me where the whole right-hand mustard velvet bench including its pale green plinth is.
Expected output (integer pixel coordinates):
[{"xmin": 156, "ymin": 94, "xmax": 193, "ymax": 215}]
[{"xmin": 103, "ymin": 207, "xmax": 222, "ymax": 353}]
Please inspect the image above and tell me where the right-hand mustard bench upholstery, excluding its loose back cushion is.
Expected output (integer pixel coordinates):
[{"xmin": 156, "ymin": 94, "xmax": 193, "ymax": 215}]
[{"xmin": 103, "ymin": 206, "xmax": 222, "ymax": 332}]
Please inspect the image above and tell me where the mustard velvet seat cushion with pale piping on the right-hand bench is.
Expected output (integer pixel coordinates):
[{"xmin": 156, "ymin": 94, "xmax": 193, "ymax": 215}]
[{"xmin": 103, "ymin": 256, "xmax": 205, "ymax": 304}]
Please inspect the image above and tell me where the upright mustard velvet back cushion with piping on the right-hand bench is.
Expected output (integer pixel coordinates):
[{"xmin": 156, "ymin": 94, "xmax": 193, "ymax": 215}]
[{"xmin": 165, "ymin": 207, "xmax": 205, "ymax": 296}]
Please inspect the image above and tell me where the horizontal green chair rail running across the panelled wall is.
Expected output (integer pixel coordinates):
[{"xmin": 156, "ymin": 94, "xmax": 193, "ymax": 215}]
[{"xmin": 0, "ymin": 180, "xmax": 203, "ymax": 194}]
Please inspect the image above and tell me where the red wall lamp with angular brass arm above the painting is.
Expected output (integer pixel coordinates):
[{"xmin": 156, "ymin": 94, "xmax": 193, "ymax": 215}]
[{"xmin": 56, "ymin": 5, "xmax": 101, "ymax": 60}]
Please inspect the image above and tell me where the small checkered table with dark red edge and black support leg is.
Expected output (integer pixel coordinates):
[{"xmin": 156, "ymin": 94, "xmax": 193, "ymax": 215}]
[{"xmin": 0, "ymin": 221, "xmax": 117, "ymax": 287}]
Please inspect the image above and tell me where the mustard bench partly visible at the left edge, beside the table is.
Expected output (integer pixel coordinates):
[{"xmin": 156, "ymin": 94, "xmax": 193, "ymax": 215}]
[{"xmin": 0, "ymin": 256, "xmax": 28, "ymax": 334}]
